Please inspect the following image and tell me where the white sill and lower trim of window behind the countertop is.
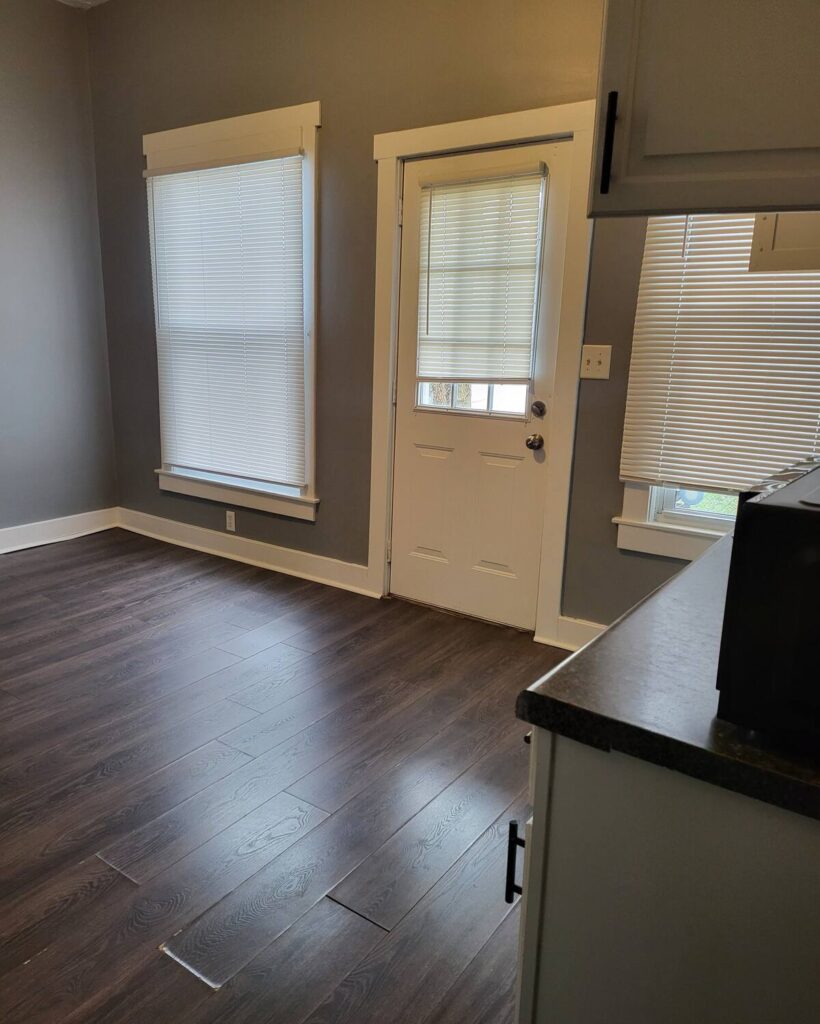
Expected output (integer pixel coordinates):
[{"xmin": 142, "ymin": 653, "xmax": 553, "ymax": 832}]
[{"xmin": 612, "ymin": 483, "xmax": 732, "ymax": 561}]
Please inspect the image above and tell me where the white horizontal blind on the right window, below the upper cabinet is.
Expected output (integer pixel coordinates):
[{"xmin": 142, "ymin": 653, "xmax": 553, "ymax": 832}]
[{"xmin": 620, "ymin": 214, "xmax": 820, "ymax": 490}]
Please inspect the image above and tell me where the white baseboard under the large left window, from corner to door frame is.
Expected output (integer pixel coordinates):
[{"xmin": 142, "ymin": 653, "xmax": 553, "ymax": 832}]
[{"xmin": 117, "ymin": 508, "xmax": 382, "ymax": 597}]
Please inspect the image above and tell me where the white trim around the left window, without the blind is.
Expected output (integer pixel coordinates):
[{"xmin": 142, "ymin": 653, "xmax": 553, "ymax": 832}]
[{"xmin": 142, "ymin": 101, "xmax": 321, "ymax": 522}]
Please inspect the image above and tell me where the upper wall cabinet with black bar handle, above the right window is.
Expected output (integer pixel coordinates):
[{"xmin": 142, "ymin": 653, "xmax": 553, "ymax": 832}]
[{"xmin": 590, "ymin": 0, "xmax": 820, "ymax": 216}]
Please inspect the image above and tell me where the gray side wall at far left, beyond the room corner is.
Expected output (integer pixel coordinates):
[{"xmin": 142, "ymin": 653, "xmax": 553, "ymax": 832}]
[{"xmin": 0, "ymin": 0, "xmax": 116, "ymax": 527}]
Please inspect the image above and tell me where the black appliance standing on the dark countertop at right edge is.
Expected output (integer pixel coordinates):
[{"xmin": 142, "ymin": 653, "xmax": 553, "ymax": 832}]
[{"xmin": 718, "ymin": 460, "xmax": 820, "ymax": 746}]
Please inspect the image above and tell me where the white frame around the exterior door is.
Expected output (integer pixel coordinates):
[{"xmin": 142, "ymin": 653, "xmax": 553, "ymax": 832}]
[{"xmin": 368, "ymin": 99, "xmax": 595, "ymax": 646}]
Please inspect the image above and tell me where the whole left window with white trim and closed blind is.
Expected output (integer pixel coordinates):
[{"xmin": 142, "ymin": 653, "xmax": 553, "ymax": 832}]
[{"xmin": 146, "ymin": 104, "xmax": 317, "ymax": 519}]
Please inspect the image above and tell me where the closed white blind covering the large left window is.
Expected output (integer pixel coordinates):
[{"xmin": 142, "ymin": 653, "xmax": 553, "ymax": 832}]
[{"xmin": 148, "ymin": 156, "xmax": 305, "ymax": 486}]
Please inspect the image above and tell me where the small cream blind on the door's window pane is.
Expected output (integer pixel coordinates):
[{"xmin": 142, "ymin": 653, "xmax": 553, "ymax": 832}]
[{"xmin": 418, "ymin": 173, "xmax": 545, "ymax": 383}]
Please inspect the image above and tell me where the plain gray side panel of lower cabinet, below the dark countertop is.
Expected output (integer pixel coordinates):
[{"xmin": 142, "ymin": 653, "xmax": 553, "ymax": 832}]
[{"xmin": 516, "ymin": 728, "xmax": 820, "ymax": 1024}]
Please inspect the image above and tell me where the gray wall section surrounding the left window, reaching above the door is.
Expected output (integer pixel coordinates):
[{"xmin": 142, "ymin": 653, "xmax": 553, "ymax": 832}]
[{"xmin": 88, "ymin": 0, "xmax": 602, "ymax": 562}]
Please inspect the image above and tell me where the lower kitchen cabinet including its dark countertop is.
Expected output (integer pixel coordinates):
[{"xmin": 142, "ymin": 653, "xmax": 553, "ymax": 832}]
[{"xmin": 509, "ymin": 537, "xmax": 820, "ymax": 1024}]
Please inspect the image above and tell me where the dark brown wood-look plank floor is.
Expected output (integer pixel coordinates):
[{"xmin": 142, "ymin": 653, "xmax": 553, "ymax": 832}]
[{"xmin": 0, "ymin": 530, "xmax": 562, "ymax": 1024}]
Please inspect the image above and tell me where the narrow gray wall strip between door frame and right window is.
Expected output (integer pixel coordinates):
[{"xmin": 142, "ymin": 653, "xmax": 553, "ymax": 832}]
[{"xmin": 563, "ymin": 218, "xmax": 686, "ymax": 624}]
